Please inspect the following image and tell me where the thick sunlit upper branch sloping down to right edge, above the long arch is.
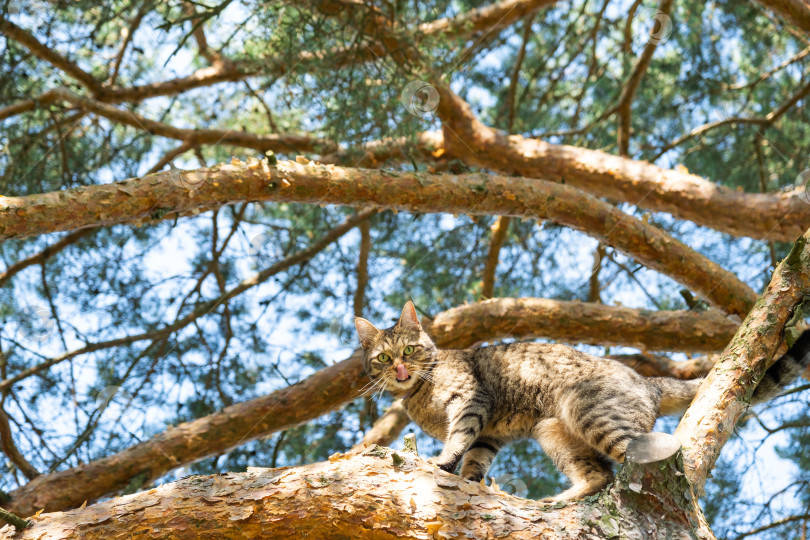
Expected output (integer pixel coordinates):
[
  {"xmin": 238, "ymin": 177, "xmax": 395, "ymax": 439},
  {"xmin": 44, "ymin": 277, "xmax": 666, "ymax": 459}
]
[{"xmin": 433, "ymin": 80, "xmax": 810, "ymax": 241}]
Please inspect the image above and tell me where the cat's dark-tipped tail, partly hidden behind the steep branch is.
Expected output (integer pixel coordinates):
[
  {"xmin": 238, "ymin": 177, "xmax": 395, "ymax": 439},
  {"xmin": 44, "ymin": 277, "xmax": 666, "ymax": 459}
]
[{"xmin": 647, "ymin": 330, "xmax": 810, "ymax": 415}]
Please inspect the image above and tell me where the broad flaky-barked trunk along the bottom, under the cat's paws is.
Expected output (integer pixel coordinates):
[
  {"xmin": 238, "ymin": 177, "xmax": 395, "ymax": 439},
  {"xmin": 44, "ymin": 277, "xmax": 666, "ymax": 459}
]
[{"xmin": 0, "ymin": 447, "xmax": 711, "ymax": 540}]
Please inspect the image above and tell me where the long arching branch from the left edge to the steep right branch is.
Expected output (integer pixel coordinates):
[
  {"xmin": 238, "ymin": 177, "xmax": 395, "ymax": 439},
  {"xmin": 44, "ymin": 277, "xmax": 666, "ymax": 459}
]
[{"xmin": 0, "ymin": 160, "xmax": 756, "ymax": 316}]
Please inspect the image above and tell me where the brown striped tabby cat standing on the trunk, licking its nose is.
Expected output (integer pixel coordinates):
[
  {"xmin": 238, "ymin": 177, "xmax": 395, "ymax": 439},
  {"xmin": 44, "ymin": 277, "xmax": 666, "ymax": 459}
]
[{"xmin": 355, "ymin": 302, "xmax": 810, "ymax": 501}]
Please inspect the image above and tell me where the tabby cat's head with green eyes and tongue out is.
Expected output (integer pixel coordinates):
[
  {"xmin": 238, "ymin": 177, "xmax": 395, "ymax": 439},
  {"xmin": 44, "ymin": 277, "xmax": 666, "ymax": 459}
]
[{"xmin": 354, "ymin": 302, "xmax": 436, "ymax": 394}]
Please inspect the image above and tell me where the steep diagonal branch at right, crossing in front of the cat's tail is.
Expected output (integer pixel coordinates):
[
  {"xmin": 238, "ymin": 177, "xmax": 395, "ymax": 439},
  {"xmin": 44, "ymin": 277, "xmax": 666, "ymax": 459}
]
[{"xmin": 675, "ymin": 231, "xmax": 810, "ymax": 491}]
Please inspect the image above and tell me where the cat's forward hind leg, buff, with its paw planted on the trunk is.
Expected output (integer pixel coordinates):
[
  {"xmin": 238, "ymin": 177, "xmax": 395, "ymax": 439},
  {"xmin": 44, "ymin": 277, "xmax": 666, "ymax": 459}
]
[{"xmin": 533, "ymin": 418, "xmax": 613, "ymax": 501}]
